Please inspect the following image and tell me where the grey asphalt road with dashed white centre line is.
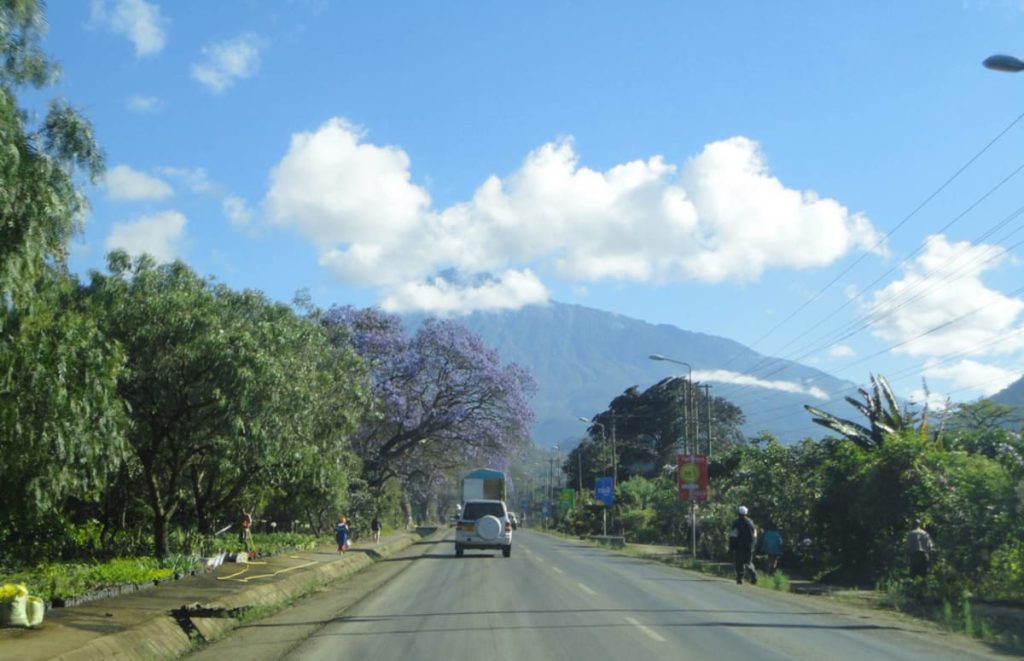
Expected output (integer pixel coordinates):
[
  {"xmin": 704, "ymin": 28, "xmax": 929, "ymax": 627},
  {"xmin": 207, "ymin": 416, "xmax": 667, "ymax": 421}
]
[{"xmin": 192, "ymin": 530, "xmax": 1007, "ymax": 661}]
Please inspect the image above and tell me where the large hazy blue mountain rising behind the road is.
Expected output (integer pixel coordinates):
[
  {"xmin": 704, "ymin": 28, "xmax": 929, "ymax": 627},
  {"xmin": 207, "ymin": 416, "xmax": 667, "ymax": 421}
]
[{"xmin": 409, "ymin": 303, "xmax": 856, "ymax": 447}]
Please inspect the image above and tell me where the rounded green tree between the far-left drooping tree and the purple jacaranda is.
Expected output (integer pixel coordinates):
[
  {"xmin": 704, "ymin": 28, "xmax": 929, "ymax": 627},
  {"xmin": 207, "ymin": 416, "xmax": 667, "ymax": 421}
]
[{"xmin": 90, "ymin": 252, "xmax": 361, "ymax": 557}]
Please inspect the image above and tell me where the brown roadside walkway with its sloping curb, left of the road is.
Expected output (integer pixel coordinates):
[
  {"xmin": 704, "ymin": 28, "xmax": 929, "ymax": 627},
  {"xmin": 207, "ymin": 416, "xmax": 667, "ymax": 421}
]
[{"xmin": 0, "ymin": 529, "xmax": 433, "ymax": 661}]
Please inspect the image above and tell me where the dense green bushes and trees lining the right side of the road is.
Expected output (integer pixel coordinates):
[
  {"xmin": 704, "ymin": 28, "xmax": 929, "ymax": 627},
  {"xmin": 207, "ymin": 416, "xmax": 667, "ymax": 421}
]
[{"xmin": 555, "ymin": 378, "xmax": 1024, "ymax": 646}]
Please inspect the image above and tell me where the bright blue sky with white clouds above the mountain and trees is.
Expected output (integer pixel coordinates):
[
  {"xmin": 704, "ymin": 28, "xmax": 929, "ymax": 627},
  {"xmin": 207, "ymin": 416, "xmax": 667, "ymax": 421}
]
[{"xmin": 39, "ymin": 0, "xmax": 1024, "ymax": 409}]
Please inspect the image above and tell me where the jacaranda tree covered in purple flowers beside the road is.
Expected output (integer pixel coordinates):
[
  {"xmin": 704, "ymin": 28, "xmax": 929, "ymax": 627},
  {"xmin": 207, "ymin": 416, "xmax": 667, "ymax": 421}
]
[{"xmin": 324, "ymin": 306, "xmax": 536, "ymax": 488}]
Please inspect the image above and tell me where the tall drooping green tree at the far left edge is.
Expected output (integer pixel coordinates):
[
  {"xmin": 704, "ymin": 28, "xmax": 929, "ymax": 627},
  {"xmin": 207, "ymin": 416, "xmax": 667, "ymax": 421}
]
[{"xmin": 0, "ymin": 0, "xmax": 123, "ymax": 560}]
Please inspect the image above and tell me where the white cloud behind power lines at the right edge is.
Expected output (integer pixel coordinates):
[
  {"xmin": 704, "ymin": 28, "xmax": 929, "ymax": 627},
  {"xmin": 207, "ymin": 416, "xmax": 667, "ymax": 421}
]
[{"xmin": 864, "ymin": 234, "xmax": 1024, "ymax": 356}]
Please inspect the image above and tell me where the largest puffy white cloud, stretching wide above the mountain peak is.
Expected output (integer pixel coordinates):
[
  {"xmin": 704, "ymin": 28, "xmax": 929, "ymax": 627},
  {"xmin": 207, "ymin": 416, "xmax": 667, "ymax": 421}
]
[{"xmin": 265, "ymin": 118, "xmax": 882, "ymax": 315}]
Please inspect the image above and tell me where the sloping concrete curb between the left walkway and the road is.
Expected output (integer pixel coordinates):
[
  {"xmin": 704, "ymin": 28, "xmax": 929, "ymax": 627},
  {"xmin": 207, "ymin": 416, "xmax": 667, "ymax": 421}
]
[{"xmin": 46, "ymin": 533, "xmax": 421, "ymax": 661}]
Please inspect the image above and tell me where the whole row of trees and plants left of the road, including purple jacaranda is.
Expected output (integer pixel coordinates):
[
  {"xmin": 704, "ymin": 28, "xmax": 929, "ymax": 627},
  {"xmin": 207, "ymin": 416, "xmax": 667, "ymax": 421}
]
[{"xmin": 0, "ymin": 0, "xmax": 532, "ymax": 598}]
